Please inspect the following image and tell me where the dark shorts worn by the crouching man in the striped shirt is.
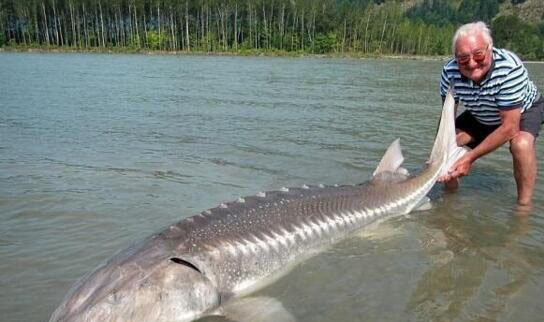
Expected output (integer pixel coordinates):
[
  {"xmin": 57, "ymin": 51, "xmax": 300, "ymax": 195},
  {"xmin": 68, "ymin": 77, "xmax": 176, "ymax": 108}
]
[{"xmin": 455, "ymin": 95, "xmax": 544, "ymax": 149}]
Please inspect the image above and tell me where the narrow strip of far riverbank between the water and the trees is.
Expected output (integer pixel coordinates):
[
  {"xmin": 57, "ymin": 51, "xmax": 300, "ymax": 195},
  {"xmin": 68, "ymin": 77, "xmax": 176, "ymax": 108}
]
[{"xmin": 0, "ymin": 46, "xmax": 448, "ymax": 60}]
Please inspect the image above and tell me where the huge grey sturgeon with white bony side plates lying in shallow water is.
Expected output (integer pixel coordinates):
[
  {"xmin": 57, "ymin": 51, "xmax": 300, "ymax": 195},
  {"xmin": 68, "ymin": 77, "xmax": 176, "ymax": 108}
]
[{"xmin": 50, "ymin": 93, "xmax": 463, "ymax": 322}]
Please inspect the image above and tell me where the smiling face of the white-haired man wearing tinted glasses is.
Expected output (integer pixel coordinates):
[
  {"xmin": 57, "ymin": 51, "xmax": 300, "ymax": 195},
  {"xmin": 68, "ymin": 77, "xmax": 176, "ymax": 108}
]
[{"xmin": 455, "ymin": 33, "xmax": 493, "ymax": 83}]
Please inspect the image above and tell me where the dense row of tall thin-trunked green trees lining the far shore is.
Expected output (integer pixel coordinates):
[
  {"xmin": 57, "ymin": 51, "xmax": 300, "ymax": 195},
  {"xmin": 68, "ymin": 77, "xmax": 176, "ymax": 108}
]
[{"xmin": 0, "ymin": 0, "xmax": 544, "ymax": 60}]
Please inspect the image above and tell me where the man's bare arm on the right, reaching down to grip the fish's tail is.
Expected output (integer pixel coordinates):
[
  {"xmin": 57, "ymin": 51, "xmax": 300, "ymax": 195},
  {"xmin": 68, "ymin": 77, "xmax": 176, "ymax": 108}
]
[{"xmin": 440, "ymin": 108, "xmax": 521, "ymax": 181}]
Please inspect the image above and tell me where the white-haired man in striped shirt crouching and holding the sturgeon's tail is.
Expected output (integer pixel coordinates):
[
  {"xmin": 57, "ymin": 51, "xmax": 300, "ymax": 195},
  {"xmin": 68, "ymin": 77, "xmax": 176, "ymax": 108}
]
[{"xmin": 440, "ymin": 22, "xmax": 544, "ymax": 205}]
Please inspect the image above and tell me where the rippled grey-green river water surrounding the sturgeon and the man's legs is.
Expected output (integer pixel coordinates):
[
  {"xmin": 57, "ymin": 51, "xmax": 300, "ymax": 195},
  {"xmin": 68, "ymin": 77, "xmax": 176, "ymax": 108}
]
[{"xmin": 0, "ymin": 53, "xmax": 544, "ymax": 322}]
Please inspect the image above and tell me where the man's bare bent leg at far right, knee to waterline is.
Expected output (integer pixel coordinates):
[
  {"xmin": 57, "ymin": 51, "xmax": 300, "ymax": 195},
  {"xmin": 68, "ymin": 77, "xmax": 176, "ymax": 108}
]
[{"xmin": 510, "ymin": 131, "xmax": 537, "ymax": 205}]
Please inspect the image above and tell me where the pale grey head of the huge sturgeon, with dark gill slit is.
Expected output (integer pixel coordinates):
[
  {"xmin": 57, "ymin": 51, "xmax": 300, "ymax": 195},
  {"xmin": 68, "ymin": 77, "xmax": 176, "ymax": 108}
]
[{"xmin": 50, "ymin": 235, "xmax": 220, "ymax": 322}]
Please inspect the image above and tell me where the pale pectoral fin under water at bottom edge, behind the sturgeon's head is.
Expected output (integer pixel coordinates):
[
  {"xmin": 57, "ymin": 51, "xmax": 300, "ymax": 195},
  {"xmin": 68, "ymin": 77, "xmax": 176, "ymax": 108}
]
[{"xmin": 221, "ymin": 296, "xmax": 296, "ymax": 322}]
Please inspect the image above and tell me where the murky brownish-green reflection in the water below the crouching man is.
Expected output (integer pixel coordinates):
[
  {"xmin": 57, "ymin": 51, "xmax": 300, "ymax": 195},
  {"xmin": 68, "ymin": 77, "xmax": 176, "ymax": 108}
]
[{"xmin": 406, "ymin": 197, "xmax": 542, "ymax": 321}]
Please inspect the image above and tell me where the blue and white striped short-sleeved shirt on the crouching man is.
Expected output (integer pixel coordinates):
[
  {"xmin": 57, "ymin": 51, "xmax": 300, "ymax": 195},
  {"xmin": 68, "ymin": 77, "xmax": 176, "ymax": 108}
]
[{"xmin": 440, "ymin": 48, "xmax": 538, "ymax": 125}]
